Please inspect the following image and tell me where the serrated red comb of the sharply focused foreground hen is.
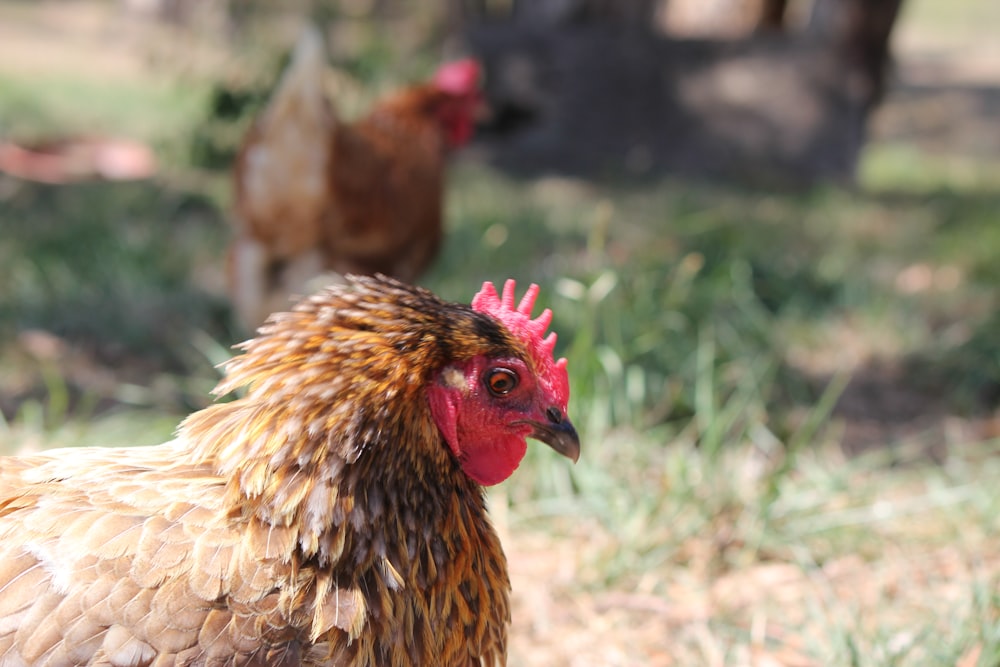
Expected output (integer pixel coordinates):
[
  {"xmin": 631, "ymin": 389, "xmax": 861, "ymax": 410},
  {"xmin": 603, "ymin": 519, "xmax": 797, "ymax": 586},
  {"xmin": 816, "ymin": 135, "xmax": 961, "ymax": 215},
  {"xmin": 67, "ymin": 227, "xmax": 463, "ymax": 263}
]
[{"xmin": 472, "ymin": 280, "xmax": 569, "ymax": 408}]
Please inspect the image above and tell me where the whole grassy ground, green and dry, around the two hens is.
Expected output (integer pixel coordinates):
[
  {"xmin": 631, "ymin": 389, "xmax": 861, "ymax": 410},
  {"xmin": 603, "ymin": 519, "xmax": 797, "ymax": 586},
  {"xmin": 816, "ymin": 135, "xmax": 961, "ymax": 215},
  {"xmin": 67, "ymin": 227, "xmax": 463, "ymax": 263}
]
[{"xmin": 0, "ymin": 2, "xmax": 1000, "ymax": 667}]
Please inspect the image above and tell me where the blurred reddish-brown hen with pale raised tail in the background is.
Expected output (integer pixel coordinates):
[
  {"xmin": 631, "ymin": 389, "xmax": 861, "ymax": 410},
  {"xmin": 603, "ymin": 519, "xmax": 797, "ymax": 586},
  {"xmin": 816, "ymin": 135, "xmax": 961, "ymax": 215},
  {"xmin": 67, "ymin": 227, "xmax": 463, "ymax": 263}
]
[{"xmin": 229, "ymin": 29, "xmax": 481, "ymax": 327}]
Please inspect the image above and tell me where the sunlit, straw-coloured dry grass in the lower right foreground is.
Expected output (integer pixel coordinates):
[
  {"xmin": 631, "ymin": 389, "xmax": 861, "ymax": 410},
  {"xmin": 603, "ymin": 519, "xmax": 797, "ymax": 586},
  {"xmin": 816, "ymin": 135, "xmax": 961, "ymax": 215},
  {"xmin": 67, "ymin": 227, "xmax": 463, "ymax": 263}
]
[{"xmin": 505, "ymin": 443, "xmax": 1000, "ymax": 667}]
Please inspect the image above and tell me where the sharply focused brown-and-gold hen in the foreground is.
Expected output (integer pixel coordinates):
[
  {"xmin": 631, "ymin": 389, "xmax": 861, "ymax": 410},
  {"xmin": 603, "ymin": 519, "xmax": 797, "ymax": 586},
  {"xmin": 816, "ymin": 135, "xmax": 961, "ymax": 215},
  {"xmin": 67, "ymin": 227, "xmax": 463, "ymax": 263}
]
[{"xmin": 0, "ymin": 276, "xmax": 580, "ymax": 667}]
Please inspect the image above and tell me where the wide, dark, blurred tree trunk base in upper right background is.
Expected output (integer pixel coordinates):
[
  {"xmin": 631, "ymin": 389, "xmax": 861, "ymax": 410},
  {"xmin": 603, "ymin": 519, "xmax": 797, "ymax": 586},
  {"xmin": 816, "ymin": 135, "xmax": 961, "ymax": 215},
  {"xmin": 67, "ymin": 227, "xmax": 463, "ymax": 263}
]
[{"xmin": 451, "ymin": 0, "xmax": 902, "ymax": 184}]
